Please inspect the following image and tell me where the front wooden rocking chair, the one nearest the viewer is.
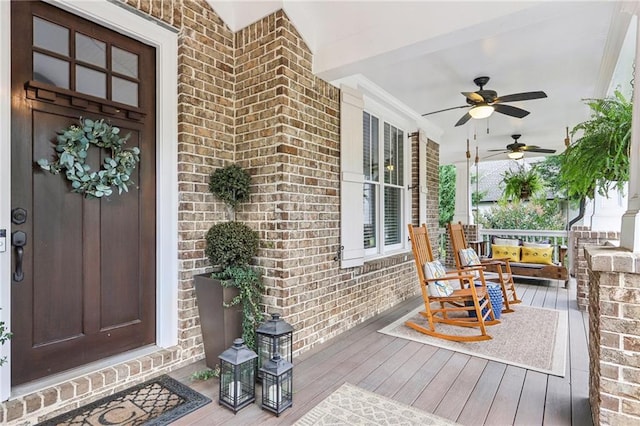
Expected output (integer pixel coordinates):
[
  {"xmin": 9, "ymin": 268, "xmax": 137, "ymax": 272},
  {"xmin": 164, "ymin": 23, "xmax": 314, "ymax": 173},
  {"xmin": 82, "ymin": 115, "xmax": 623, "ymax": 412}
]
[{"xmin": 405, "ymin": 225, "xmax": 500, "ymax": 342}]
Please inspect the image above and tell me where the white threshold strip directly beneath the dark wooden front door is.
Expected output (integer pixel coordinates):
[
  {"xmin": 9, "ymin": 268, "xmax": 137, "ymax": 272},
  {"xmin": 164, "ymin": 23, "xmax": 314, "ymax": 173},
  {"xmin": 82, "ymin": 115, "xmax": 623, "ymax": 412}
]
[{"xmin": 11, "ymin": 345, "xmax": 162, "ymax": 398}]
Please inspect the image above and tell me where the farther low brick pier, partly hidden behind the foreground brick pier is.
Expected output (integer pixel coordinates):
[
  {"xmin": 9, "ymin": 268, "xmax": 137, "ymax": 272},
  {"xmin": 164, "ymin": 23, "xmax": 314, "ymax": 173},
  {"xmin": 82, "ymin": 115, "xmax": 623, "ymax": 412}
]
[{"xmin": 569, "ymin": 226, "xmax": 620, "ymax": 311}]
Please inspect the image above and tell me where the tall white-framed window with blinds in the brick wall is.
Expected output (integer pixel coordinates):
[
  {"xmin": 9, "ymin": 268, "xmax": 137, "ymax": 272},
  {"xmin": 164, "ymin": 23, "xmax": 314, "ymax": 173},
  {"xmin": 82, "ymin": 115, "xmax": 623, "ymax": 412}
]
[{"xmin": 362, "ymin": 111, "xmax": 405, "ymax": 255}]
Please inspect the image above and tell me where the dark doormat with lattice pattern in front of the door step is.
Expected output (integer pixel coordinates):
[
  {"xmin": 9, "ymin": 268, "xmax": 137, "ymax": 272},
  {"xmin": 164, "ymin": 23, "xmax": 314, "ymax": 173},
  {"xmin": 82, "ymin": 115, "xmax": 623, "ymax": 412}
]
[{"xmin": 39, "ymin": 375, "xmax": 211, "ymax": 426}]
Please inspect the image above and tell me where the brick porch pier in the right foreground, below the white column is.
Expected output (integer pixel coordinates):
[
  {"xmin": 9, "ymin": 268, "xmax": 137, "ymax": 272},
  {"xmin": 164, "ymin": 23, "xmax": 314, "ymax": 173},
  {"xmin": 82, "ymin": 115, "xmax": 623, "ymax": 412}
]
[{"xmin": 585, "ymin": 246, "xmax": 640, "ymax": 425}]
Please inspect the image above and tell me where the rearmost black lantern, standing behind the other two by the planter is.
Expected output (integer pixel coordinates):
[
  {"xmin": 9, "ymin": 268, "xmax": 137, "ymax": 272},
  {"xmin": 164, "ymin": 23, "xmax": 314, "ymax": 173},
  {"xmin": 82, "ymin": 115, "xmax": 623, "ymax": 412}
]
[{"xmin": 256, "ymin": 313, "xmax": 293, "ymax": 378}]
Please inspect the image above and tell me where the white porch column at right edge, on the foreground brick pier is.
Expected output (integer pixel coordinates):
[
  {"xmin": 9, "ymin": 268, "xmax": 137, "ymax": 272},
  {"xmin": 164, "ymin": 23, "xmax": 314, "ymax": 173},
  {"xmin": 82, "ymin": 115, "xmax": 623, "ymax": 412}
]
[{"xmin": 620, "ymin": 12, "xmax": 640, "ymax": 253}]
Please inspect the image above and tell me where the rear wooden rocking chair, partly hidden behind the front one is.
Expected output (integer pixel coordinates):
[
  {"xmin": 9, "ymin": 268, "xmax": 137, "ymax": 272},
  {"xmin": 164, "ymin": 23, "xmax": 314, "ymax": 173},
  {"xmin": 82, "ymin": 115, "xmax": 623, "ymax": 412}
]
[{"xmin": 447, "ymin": 222, "xmax": 521, "ymax": 313}]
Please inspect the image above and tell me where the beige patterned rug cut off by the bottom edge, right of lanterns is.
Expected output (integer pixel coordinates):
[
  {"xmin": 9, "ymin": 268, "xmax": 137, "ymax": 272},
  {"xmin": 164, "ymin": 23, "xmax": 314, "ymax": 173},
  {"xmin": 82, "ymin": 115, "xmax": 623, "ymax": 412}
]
[{"xmin": 294, "ymin": 383, "xmax": 456, "ymax": 426}]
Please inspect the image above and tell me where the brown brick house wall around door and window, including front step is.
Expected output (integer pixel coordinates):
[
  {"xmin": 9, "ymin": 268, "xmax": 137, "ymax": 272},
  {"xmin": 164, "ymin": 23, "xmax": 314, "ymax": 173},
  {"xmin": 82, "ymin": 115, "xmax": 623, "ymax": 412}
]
[{"xmin": 0, "ymin": 0, "xmax": 439, "ymax": 425}]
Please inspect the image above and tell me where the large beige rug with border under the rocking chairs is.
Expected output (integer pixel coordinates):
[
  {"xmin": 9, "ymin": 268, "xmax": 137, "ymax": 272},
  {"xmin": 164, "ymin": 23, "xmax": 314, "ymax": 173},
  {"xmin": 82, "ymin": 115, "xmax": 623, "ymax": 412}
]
[{"xmin": 378, "ymin": 304, "xmax": 568, "ymax": 377}]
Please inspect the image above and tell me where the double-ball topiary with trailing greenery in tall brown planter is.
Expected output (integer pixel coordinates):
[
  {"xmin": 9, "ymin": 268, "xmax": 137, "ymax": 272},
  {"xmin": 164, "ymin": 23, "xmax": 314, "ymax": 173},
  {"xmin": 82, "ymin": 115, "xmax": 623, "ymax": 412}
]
[{"xmin": 194, "ymin": 164, "xmax": 264, "ymax": 368}]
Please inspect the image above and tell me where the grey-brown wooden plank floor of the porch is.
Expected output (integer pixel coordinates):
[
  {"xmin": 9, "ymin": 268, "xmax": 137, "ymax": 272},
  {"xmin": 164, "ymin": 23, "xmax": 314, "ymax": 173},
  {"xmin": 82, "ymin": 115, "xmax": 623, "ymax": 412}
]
[{"xmin": 172, "ymin": 280, "xmax": 592, "ymax": 426}]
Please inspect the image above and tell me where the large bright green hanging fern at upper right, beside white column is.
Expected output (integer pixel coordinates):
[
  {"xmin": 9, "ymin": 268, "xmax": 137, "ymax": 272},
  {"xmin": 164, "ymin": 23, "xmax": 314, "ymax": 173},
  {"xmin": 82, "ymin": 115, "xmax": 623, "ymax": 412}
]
[{"xmin": 560, "ymin": 91, "xmax": 632, "ymax": 199}]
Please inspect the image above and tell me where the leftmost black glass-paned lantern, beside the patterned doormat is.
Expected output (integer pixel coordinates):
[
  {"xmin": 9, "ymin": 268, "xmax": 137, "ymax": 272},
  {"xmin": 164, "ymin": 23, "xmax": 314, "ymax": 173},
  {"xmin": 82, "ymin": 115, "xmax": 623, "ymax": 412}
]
[{"xmin": 218, "ymin": 339, "xmax": 258, "ymax": 413}]
